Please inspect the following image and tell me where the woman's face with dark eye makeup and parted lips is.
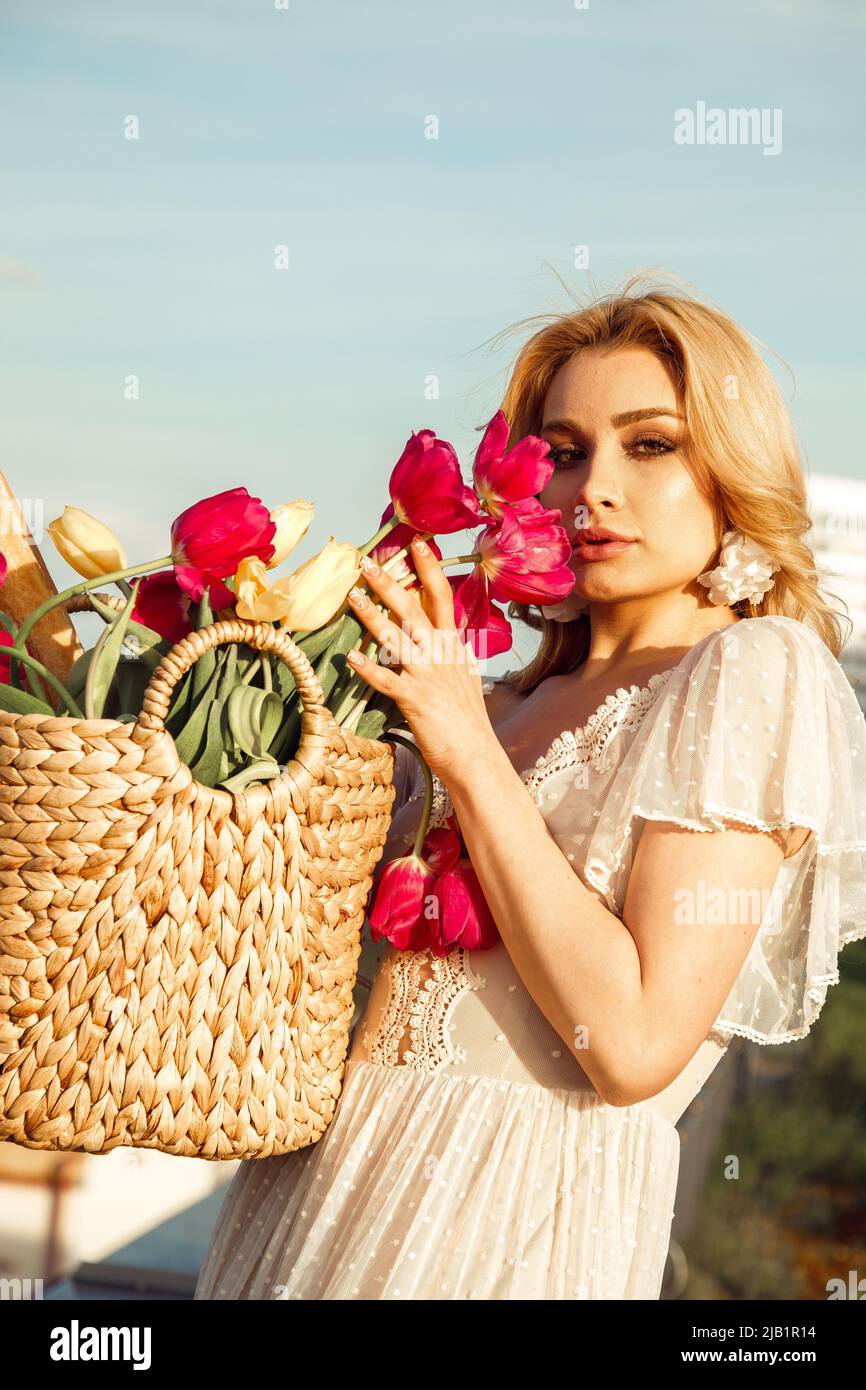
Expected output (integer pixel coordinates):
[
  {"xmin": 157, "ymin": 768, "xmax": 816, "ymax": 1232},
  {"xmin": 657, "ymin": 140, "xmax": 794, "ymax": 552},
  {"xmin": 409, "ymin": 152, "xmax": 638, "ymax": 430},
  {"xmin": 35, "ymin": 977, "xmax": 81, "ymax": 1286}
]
[{"xmin": 539, "ymin": 348, "xmax": 719, "ymax": 603}]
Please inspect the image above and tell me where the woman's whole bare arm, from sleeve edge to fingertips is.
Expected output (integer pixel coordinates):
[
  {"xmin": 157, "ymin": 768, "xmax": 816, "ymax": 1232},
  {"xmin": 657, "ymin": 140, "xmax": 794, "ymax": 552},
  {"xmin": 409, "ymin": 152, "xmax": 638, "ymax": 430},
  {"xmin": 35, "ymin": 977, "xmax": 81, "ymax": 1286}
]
[{"xmin": 348, "ymin": 542, "xmax": 783, "ymax": 1105}]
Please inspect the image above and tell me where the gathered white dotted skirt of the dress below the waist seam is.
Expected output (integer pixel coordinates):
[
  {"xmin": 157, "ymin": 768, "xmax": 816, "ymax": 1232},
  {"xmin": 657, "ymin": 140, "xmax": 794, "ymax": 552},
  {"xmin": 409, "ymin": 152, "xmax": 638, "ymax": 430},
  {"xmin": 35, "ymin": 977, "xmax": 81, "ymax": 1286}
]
[{"xmin": 196, "ymin": 1062, "xmax": 680, "ymax": 1300}]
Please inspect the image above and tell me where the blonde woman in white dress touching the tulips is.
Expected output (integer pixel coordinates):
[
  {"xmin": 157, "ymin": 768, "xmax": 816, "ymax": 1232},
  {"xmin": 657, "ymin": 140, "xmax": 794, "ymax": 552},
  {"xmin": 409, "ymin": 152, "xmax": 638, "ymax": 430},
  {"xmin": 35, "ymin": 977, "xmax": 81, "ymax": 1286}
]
[{"xmin": 196, "ymin": 273, "xmax": 866, "ymax": 1300}]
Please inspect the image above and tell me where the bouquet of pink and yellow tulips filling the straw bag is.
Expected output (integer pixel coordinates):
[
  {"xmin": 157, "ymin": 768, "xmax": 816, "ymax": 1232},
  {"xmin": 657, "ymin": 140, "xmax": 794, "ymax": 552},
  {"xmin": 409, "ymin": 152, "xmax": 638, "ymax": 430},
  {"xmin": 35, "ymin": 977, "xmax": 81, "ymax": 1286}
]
[{"xmin": 0, "ymin": 411, "xmax": 574, "ymax": 856}]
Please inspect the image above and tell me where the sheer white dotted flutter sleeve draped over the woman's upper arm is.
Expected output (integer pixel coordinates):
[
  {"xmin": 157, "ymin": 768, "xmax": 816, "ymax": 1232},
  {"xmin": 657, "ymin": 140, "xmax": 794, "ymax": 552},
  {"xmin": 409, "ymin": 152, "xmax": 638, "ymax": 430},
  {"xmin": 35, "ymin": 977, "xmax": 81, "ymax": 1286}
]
[{"xmin": 584, "ymin": 616, "xmax": 866, "ymax": 1043}]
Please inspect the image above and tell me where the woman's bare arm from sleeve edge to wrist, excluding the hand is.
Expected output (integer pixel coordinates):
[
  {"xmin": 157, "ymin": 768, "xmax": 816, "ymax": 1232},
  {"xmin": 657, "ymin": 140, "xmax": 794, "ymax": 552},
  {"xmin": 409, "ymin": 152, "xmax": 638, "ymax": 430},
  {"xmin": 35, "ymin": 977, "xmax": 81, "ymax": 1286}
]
[{"xmin": 448, "ymin": 739, "xmax": 783, "ymax": 1105}]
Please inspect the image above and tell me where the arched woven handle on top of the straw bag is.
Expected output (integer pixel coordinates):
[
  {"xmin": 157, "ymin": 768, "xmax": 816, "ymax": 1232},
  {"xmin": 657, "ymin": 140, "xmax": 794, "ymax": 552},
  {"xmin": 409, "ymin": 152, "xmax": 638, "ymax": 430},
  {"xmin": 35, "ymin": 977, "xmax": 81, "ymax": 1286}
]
[{"xmin": 138, "ymin": 617, "xmax": 330, "ymax": 737}]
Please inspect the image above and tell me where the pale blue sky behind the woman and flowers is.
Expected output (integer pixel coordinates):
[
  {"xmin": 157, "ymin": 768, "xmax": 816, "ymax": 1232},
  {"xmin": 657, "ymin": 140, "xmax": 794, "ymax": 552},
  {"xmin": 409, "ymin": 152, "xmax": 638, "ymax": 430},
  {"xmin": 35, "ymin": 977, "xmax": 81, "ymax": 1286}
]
[{"xmin": 0, "ymin": 0, "xmax": 866, "ymax": 671}]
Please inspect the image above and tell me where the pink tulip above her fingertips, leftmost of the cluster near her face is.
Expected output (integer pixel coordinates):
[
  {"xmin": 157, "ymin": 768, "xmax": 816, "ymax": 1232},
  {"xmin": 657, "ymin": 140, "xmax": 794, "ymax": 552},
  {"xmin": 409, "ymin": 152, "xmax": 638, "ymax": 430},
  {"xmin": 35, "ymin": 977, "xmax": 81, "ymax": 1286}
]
[{"xmin": 388, "ymin": 430, "xmax": 481, "ymax": 535}]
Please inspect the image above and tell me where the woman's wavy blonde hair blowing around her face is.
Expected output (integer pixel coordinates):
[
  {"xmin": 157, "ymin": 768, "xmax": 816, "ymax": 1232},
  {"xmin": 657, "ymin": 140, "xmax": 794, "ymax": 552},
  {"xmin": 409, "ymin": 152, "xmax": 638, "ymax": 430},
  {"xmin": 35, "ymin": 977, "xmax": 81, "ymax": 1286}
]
[{"xmin": 480, "ymin": 271, "xmax": 851, "ymax": 694}]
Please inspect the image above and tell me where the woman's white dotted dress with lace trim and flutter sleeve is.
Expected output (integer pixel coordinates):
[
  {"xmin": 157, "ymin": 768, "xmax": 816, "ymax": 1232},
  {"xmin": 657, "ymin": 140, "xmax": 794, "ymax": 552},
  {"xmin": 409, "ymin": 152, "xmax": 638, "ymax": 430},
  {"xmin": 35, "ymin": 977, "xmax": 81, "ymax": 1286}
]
[{"xmin": 195, "ymin": 617, "xmax": 866, "ymax": 1300}]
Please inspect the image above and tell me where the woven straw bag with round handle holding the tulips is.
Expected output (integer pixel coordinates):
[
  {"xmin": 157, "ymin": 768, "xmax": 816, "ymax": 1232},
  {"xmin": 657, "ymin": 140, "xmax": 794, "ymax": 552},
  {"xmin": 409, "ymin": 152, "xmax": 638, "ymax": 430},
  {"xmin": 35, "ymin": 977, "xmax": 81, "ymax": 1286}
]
[{"xmin": 0, "ymin": 599, "xmax": 395, "ymax": 1159}]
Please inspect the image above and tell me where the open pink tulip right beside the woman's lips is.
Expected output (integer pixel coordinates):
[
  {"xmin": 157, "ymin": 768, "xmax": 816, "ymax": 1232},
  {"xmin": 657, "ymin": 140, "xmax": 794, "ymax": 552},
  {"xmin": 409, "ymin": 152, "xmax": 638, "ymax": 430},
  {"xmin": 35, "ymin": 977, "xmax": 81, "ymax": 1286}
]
[{"xmin": 475, "ymin": 498, "xmax": 574, "ymax": 603}]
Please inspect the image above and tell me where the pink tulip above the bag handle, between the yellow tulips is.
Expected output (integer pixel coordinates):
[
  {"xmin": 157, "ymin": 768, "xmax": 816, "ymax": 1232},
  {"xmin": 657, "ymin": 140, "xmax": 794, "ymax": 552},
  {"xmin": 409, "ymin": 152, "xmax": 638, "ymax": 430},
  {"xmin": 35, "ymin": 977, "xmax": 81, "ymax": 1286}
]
[{"xmin": 171, "ymin": 488, "xmax": 277, "ymax": 607}]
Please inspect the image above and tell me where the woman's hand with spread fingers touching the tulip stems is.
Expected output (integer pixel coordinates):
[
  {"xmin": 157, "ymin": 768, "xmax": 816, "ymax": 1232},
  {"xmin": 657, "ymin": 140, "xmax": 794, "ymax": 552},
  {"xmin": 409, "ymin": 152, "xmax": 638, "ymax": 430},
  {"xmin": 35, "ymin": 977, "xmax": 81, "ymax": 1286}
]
[{"xmin": 348, "ymin": 542, "xmax": 496, "ymax": 781}]
